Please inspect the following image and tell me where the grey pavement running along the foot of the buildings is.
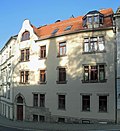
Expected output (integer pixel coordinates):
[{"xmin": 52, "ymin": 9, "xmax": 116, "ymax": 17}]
[{"xmin": 0, "ymin": 116, "xmax": 120, "ymax": 131}]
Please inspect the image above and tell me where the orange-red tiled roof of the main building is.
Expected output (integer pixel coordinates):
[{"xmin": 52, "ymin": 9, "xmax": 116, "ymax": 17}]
[{"xmin": 32, "ymin": 8, "xmax": 114, "ymax": 39}]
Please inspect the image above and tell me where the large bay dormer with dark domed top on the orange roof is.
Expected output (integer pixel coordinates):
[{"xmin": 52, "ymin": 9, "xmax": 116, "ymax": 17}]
[{"xmin": 83, "ymin": 11, "xmax": 104, "ymax": 28}]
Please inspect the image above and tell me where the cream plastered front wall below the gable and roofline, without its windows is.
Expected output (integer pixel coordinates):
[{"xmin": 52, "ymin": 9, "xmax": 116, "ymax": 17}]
[{"xmin": 13, "ymin": 22, "xmax": 115, "ymax": 122}]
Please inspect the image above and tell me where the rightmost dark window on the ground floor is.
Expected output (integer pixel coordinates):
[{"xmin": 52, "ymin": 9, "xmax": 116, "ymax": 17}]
[{"xmin": 99, "ymin": 96, "xmax": 107, "ymax": 112}]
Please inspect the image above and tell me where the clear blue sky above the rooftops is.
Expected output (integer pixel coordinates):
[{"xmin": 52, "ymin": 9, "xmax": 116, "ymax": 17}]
[{"xmin": 0, "ymin": 0, "xmax": 120, "ymax": 49}]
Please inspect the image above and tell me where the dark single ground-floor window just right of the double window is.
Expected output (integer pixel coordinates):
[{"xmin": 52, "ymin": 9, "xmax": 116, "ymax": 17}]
[{"xmin": 58, "ymin": 95, "xmax": 65, "ymax": 110}]
